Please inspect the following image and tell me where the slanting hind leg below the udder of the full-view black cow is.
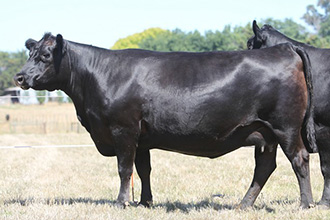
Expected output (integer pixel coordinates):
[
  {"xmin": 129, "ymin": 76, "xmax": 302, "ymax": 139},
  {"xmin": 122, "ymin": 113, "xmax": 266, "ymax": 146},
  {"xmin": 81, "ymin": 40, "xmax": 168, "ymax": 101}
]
[{"xmin": 239, "ymin": 144, "xmax": 277, "ymax": 209}]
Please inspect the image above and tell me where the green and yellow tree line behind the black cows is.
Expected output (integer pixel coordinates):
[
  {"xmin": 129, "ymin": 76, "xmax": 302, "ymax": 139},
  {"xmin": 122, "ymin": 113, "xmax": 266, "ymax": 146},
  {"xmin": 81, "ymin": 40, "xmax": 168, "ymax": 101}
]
[{"xmin": 0, "ymin": 0, "xmax": 330, "ymax": 95}]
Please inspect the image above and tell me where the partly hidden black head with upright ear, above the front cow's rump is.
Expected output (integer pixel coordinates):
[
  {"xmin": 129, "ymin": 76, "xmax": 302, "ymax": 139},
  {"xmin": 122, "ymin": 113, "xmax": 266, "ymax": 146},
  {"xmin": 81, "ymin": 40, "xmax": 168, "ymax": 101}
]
[{"xmin": 247, "ymin": 21, "xmax": 287, "ymax": 50}]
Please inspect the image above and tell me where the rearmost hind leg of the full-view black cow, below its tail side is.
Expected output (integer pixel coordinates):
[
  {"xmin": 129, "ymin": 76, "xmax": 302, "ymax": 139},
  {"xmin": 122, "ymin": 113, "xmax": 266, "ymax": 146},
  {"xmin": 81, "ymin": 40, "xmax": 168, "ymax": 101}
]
[{"xmin": 279, "ymin": 132, "xmax": 314, "ymax": 208}]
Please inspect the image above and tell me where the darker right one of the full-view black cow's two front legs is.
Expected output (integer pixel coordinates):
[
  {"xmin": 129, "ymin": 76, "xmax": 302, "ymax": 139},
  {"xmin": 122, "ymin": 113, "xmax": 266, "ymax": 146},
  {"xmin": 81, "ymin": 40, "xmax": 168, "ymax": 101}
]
[{"xmin": 135, "ymin": 148, "xmax": 152, "ymax": 207}]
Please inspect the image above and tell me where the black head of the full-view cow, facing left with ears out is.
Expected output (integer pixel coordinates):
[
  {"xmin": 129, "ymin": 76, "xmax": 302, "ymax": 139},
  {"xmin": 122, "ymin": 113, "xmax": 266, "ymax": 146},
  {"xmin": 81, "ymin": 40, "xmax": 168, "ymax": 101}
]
[{"xmin": 14, "ymin": 33, "xmax": 65, "ymax": 90}]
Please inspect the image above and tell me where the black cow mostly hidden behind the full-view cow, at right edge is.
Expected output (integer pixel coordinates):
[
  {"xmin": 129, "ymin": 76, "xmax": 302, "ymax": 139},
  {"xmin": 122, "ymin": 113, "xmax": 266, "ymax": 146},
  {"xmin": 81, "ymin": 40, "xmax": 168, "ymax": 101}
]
[{"xmin": 247, "ymin": 21, "xmax": 330, "ymax": 207}]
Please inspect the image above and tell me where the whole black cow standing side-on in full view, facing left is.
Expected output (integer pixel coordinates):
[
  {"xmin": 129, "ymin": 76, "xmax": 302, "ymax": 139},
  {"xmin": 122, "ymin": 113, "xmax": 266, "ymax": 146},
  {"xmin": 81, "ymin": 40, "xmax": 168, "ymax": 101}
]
[{"xmin": 14, "ymin": 34, "xmax": 315, "ymax": 207}]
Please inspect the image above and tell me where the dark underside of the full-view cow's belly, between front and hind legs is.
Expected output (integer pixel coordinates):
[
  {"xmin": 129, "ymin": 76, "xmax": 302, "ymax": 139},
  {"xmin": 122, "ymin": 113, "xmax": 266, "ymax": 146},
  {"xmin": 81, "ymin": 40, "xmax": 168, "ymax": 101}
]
[{"xmin": 138, "ymin": 121, "xmax": 264, "ymax": 158}]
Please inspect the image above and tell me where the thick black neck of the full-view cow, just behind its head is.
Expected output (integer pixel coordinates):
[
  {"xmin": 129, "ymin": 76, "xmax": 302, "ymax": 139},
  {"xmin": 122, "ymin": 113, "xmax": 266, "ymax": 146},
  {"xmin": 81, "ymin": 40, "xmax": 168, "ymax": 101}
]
[{"xmin": 63, "ymin": 42, "xmax": 115, "ymax": 130}]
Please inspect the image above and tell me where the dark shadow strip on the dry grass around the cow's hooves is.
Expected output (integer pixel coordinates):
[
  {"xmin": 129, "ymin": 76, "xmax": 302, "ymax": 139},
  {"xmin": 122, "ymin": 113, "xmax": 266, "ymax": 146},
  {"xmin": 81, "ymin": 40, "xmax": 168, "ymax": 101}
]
[{"xmin": 4, "ymin": 195, "xmax": 288, "ymax": 213}]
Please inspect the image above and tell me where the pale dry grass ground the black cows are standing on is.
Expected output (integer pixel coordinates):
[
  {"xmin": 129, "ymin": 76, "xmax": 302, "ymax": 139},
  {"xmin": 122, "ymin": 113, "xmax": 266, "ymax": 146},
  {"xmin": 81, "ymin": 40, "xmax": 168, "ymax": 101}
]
[{"xmin": 0, "ymin": 106, "xmax": 330, "ymax": 220}]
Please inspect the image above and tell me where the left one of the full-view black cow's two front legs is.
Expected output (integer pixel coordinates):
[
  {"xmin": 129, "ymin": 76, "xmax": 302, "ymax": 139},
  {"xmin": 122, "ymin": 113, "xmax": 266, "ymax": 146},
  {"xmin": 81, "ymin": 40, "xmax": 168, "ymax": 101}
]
[{"xmin": 116, "ymin": 140, "xmax": 136, "ymax": 208}]
